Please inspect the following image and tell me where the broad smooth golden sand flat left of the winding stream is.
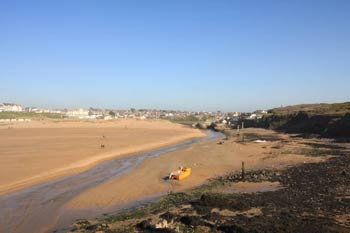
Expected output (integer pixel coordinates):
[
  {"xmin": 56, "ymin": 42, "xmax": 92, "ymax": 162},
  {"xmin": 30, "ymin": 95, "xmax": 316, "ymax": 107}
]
[{"xmin": 0, "ymin": 119, "xmax": 205, "ymax": 194}]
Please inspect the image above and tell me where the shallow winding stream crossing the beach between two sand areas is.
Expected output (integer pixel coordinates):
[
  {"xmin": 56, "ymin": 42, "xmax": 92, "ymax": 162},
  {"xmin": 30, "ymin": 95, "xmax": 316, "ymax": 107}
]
[{"xmin": 0, "ymin": 131, "xmax": 223, "ymax": 233}]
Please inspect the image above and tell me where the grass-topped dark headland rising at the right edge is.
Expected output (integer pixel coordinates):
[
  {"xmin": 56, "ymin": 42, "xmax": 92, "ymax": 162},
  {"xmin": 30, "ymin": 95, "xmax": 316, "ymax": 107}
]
[{"xmin": 244, "ymin": 102, "xmax": 350, "ymax": 140}]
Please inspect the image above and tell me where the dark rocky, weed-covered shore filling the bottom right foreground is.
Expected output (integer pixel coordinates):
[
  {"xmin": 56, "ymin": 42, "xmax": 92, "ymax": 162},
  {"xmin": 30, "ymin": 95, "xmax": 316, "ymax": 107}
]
[{"xmin": 72, "ymin": 136, "xmax": 350, "ymax": 233}]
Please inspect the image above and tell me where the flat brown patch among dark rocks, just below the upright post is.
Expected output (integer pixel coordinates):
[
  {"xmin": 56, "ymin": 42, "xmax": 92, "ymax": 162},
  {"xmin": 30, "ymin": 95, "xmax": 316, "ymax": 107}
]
[{"xmin": 216, "ymin": 181, "xmax": 282, "ymax": 193}]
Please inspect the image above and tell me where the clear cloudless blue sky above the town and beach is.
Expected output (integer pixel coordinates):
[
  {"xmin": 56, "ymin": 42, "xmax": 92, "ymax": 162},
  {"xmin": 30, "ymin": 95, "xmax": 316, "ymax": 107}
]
[{"xmin": 0, "ymin": 0, "xmax": 350, "ymax": 111}]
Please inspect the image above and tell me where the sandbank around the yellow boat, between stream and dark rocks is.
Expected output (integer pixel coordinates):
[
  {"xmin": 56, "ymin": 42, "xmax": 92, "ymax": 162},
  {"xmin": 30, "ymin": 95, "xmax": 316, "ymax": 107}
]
[{"xmin": 66, "ymin": 129, "xmax": 326, "ymax": 209}]
